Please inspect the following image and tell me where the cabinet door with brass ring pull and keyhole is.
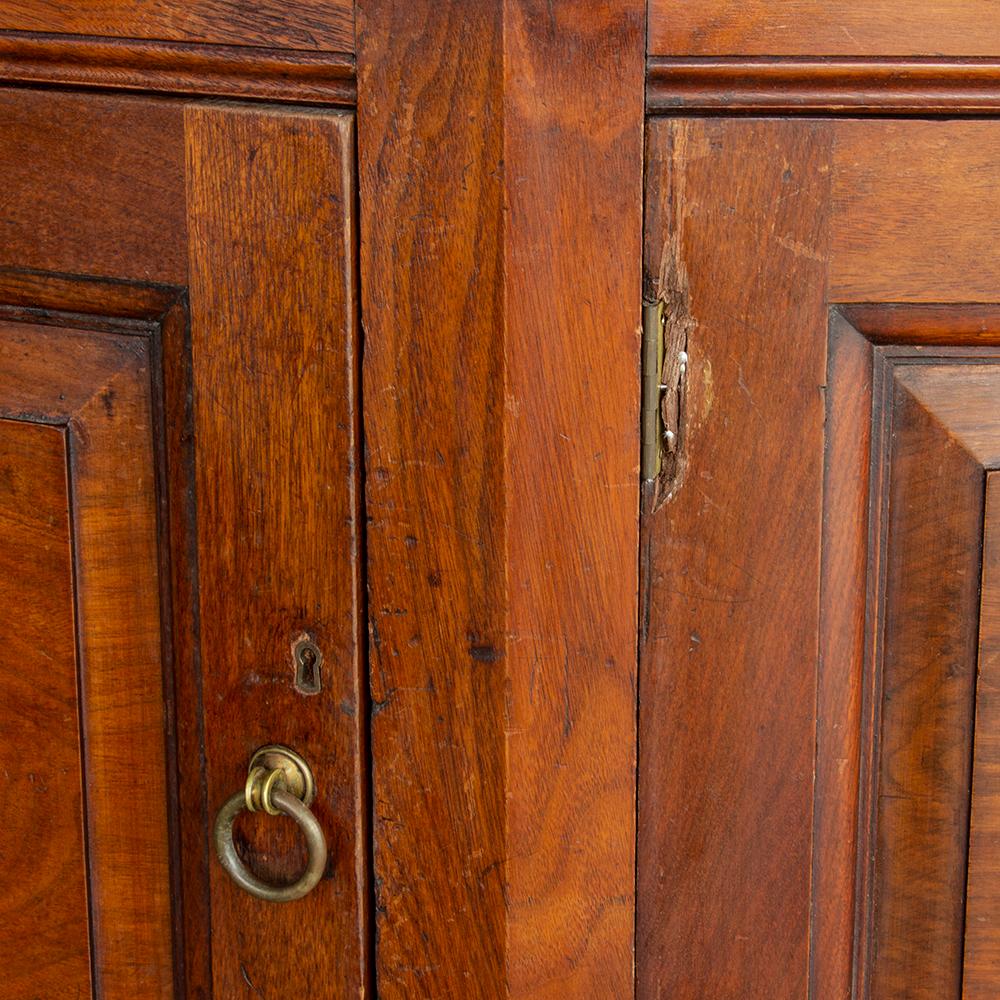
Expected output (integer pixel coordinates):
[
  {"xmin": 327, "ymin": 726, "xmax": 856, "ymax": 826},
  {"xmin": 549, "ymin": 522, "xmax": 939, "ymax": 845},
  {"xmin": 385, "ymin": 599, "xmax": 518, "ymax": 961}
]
[{"xmin": 0, "ymin": 91, "xmax": 368, "ymax": 1000}]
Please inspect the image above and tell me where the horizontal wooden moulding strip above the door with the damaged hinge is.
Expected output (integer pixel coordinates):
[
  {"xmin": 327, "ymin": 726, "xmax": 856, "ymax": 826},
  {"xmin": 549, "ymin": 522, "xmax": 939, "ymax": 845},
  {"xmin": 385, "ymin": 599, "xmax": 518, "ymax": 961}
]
[{"xmin": 646, "ymin": 56, "xmax": 1000, "ymax": 116}]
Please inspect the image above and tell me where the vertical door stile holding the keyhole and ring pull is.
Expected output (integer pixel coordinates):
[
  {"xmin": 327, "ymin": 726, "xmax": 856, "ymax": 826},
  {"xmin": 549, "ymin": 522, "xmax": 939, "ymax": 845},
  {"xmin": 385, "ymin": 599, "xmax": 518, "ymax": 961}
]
[{"xmin": 185, "ymin": 106, "xmax": 368, "ymax": 997}]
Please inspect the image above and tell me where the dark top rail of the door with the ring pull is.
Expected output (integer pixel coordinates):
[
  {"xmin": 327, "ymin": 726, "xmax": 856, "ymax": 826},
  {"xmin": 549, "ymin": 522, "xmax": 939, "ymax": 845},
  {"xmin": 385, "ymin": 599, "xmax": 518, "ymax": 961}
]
[{"xmin": 0, "ymin": 90, "xmax": 187, "ymax": 285}]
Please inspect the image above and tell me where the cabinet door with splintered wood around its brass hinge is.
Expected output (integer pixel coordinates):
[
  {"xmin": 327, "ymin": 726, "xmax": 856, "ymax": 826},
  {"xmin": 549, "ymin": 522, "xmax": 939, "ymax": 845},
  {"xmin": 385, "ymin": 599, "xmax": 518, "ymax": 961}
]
[{"xmin": 638, "ymin": 119, "xmax": 1000, "ymax": 1000}]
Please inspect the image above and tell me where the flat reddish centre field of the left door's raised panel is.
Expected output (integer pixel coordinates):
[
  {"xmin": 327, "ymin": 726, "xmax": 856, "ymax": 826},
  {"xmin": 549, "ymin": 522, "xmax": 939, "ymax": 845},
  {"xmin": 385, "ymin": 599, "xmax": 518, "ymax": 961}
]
[{"xmin": 0, "ymin": 420, "xmax": 92, "ymax": 1000}]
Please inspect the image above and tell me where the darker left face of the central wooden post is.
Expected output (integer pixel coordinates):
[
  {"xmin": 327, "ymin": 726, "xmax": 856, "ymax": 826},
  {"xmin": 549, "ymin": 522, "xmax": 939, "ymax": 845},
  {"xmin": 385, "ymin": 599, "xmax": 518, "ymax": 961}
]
[{"xmin": 358, "ymin": 0, "xmax": 507, "ymax": 1000}]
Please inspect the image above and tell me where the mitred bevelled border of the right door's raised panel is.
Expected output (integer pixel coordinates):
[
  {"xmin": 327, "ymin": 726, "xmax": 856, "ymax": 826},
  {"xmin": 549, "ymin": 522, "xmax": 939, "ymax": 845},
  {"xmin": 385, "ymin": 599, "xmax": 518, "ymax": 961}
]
[{"xmin": 868, "ymin": 364, "xmax": 984, "ymax": 1000}]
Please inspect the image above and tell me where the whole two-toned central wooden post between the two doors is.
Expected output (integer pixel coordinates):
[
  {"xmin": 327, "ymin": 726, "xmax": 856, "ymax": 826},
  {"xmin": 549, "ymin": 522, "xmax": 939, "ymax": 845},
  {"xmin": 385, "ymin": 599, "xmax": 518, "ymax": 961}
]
[{"xmin": 358, "ymin": 0, "xmax": 643, "ymax": 998}]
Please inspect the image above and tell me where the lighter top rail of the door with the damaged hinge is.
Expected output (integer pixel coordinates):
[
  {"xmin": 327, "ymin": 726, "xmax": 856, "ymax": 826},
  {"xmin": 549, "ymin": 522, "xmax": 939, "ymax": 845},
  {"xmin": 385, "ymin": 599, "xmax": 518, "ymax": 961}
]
[{"xmin": 829, "ymin": 121, "xmax": 1000, "ymax": 302}]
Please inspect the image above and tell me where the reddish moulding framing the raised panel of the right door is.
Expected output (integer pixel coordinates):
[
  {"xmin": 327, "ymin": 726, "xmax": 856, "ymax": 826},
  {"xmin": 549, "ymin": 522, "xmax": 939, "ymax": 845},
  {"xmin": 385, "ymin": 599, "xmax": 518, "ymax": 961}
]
[{"xmin": 809, "ymin": 303, "xmax": 1000, "ymax": 998}]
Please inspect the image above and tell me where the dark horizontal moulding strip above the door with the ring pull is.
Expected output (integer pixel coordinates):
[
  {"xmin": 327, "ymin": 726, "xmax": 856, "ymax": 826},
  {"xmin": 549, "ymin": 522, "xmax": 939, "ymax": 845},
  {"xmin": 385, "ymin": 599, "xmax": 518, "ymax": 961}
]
[{"xmin": 0, "ymin": 31, "xmax": 357, "ymax": 106}]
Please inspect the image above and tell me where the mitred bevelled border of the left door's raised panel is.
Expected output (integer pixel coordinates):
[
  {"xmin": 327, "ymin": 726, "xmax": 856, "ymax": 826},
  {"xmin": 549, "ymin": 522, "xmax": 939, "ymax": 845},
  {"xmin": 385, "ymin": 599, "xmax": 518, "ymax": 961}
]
[{"xmin": 0, "ymin": 322, "xmax": 178, "ymax": 1000}]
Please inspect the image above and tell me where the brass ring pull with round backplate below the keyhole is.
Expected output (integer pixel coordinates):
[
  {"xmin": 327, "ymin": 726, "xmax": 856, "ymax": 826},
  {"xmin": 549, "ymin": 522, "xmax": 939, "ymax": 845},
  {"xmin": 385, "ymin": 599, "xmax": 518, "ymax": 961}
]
[{"xmin": 215, "ymin": 744, "xmax": 327, "ymax": 903}]
